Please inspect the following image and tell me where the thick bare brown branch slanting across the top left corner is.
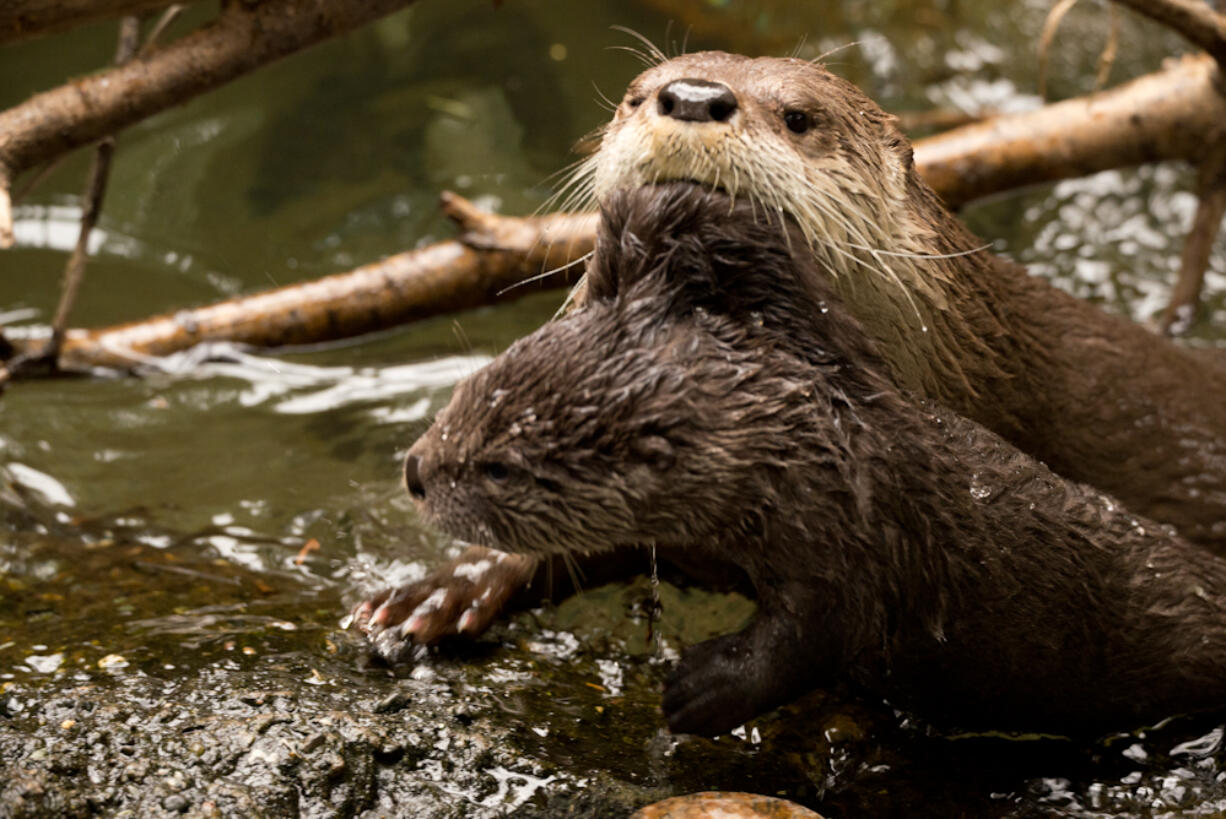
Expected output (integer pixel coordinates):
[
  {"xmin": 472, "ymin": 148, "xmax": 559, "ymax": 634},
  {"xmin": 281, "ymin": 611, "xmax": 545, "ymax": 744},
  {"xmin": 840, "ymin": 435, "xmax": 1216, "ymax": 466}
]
[{"xmin": 0, "ymin": 0, "xmax": 413, "ymax": 248}]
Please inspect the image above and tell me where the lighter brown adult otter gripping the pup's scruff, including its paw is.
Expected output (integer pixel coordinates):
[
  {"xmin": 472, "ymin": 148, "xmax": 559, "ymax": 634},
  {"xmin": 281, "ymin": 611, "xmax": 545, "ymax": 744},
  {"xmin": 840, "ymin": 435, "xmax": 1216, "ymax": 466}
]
[{"xmin": 356, "ymin": 53, "xmax": 1226, "ymax": 642}]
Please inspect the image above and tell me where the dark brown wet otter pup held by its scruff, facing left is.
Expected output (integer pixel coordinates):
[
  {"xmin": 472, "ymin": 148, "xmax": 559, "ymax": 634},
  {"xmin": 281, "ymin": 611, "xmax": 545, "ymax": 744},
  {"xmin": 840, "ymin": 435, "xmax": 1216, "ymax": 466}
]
[{"xmin": 380, "ymin": 184, "xmax": 1226, "ymax": 734}]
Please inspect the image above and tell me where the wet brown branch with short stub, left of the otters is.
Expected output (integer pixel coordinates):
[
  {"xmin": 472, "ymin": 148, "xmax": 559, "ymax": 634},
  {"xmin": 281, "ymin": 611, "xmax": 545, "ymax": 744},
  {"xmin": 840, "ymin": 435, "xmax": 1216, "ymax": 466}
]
[{"xmin": 10, "ymin": 194, "xmax": 596, "ymax": 371}]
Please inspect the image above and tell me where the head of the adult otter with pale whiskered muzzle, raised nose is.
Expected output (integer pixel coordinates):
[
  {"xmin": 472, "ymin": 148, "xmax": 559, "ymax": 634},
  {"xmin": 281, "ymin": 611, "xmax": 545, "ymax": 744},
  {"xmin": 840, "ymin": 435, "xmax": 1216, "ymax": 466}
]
[{"xmin": 587, "ymin": 51, "xmax": 912, "ymax": 272}]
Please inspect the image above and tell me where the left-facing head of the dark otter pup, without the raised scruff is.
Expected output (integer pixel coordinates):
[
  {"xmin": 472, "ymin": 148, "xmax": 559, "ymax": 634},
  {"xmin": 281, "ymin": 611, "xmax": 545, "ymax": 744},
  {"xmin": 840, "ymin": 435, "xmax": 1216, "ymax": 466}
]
[{"xmin": 405, "ymin": 304, "xmax": 765, "ymax": 554}]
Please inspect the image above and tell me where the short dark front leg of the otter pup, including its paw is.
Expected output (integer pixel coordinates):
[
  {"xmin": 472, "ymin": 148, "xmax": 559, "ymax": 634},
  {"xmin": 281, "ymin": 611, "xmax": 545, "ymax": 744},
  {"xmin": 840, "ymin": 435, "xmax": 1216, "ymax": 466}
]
[{"xmin": 663, "ymin": 607, "xmax": 835, "ymax": 737}]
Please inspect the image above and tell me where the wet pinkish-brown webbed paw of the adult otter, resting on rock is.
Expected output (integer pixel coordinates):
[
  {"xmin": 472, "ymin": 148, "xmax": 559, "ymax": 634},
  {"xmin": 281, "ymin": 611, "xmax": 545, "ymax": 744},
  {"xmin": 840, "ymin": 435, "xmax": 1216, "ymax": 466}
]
[{"xmin": 348, "ymin": 547, "xmax": 536, "ymax": 663}]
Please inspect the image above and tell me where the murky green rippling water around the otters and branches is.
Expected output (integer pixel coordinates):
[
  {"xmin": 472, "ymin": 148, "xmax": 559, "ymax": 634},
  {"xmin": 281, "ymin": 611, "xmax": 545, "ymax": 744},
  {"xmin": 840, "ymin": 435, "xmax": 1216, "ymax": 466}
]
[{"xmin": 0, "ymin": 0, "xmax": 1226, "ymax": 817}]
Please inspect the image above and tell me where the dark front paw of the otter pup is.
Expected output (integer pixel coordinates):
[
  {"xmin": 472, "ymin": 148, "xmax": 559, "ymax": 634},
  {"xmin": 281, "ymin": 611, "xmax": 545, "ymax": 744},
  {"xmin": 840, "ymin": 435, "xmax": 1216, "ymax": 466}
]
[{"xmin": 662, "ymin": 634, "xmax": 758, "ymax": 737}]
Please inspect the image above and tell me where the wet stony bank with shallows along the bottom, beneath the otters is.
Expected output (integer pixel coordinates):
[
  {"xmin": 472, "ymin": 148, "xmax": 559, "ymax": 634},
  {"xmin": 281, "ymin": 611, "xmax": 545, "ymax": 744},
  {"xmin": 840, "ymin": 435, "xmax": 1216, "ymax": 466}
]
[{"xmin": 7, "ymin": 520, "xmax": 1226, "ymax": 817}]
